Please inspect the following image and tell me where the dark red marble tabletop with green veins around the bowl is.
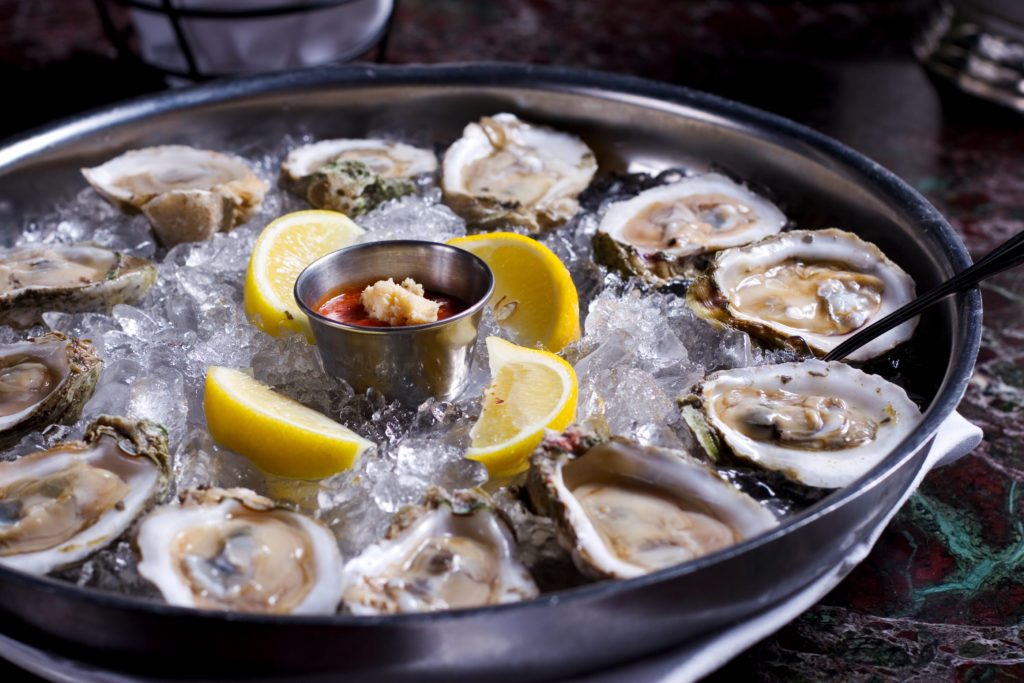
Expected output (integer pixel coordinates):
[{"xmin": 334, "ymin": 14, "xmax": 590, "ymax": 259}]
[{"xmin": 0, "ymin": 0, "xmax": 1024, "ymax": 682}]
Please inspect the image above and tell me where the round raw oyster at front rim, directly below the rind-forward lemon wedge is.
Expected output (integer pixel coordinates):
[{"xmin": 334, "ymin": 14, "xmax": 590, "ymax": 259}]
[{"xmin": 135, "ymin": 488, "xmax": 342, "ymax": 614}]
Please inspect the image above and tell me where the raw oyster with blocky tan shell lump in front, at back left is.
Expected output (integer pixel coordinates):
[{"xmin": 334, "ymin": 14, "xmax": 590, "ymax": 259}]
[{"xmin": 82, "ymin": 144, "xmax": 267, "ymax": 247}]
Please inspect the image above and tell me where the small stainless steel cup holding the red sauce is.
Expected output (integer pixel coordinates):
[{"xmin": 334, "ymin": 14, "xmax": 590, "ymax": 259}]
[{"xmin": 295, "ymin": 240, "xmax": 495, "ymax": 405}]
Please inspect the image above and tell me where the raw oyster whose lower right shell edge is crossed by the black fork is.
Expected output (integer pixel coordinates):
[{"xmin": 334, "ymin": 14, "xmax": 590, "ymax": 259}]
[{"xmin": 688, "ymin": 228, "xmax": 918, "ymax": 360}]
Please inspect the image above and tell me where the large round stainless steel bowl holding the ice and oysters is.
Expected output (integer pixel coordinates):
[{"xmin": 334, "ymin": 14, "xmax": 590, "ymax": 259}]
[{"xmin": 0, "ymin": 65, "xmax": 981, "ymax": 681}]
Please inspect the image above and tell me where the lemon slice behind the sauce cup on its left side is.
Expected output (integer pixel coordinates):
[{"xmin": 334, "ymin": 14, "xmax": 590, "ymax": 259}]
[{"xmin": 245, "ymin": 206, "xmax": 364, "ymax": 343}]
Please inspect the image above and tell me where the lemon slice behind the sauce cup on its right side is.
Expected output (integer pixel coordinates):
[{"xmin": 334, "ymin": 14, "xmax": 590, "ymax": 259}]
[{"xmin": 449, "ymin": 232, "xmax": 580, "ymax": 353}]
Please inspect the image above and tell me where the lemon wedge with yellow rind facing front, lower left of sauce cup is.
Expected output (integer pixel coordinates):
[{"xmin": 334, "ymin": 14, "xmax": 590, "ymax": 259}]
[{"xmin": 203, "ymin": 366, "xmax": 373, "ymax": 479}]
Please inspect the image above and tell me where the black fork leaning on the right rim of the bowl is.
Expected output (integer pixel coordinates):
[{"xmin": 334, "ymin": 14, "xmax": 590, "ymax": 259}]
[{"xmin": 824, "ymin": 231, "xmax": 1024, "ymax": 360}]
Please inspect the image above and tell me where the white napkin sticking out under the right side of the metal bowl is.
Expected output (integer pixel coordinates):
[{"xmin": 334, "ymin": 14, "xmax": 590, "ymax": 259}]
[{"xmin": 587, "ymin": 413, "xmax": 982, "ymax": 683}]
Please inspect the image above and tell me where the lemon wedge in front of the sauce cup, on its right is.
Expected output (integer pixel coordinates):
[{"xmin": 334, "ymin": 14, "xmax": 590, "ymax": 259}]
[{"xmin": 466, "ymin": 337, "xmax": 578, "ymax": 477}]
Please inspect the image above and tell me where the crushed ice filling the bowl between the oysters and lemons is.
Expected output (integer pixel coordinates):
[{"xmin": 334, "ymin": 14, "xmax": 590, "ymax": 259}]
[{"xmin": 6, "ymin": 139, "xmax": 767, "ymax": 596}]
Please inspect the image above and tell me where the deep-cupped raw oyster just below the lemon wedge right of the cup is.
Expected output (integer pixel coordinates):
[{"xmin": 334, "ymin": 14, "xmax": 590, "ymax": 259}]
[{"xmin": 526, "ymin": 427, "xmax": 777, "ymax": 579}]
